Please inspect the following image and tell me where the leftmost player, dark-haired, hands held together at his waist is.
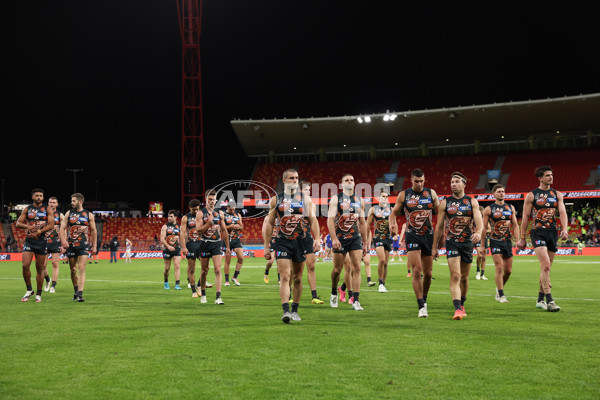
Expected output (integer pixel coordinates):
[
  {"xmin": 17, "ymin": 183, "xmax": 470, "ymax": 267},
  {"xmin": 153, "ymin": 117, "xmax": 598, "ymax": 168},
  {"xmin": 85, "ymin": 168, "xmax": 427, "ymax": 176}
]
[{"xmin": 17, "ymin": 188, "xmax": 55, "ymax": 303}]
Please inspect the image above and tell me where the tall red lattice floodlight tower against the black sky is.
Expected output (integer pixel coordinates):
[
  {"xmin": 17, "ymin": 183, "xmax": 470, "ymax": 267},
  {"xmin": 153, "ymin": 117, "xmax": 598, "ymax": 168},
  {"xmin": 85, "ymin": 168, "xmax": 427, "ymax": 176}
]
[{"xmin": 177, "ymin": 0, "xmax": 205, "ymax": 213}]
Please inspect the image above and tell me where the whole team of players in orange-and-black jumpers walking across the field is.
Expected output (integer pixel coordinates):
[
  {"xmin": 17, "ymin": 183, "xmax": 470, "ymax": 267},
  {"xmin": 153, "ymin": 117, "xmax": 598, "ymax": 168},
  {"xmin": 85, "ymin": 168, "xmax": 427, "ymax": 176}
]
[{"xmin": 17, "ymin": 166, "xmax": 567, "ymax": 323}]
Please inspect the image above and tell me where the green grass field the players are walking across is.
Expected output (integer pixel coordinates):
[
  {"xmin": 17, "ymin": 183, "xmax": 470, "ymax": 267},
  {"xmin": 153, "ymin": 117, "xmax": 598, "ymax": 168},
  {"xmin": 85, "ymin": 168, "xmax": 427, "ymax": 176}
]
[{"xmin": 0, "ymin": 256, "xmax": 600, "ymax": 400}]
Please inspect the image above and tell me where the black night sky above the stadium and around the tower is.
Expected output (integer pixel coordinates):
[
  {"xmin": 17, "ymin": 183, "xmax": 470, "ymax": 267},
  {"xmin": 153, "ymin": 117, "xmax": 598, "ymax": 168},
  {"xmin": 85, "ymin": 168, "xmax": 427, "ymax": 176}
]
[{"xmin": 1, "ymin": 0, "xmax": 600, "ymax": 211}]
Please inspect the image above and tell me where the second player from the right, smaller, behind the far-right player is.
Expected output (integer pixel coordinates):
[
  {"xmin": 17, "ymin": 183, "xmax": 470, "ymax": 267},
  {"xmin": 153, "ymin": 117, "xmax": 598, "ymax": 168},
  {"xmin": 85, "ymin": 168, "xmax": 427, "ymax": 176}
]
[{"xmin": 483, "ymin": 184, "xmax": 519, "ymax": 303}]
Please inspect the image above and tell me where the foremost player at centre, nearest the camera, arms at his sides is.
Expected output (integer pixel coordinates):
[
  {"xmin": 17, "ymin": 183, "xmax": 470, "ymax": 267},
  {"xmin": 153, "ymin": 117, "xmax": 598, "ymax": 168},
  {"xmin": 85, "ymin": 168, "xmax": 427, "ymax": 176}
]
[{"xmin": 263, "ymin": 169, "xmax": 321, "ymax": 324}]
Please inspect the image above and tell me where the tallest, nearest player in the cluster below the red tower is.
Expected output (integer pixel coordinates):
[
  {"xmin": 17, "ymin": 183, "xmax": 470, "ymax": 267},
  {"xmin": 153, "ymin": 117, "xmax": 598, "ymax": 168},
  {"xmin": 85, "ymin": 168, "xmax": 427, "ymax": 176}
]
[{"xmin": 196, "ymin": 189, "xmax": 231, "ymax": 305}]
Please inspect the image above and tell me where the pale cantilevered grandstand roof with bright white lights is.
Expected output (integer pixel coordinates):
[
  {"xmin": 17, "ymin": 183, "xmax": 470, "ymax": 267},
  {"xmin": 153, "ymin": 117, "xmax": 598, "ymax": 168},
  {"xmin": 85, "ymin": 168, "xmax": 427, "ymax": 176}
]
[{"xmin": 231, "ymin": 93, "xmax": 600, "ymax": 156}]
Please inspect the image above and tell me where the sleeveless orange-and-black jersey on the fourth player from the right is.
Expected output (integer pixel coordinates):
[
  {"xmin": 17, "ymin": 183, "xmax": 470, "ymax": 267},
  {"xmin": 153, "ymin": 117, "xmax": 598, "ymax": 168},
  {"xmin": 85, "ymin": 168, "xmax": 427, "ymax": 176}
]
[{"xmin": 404, "ymin": 188, "xmax": 433, "ymax": 235}]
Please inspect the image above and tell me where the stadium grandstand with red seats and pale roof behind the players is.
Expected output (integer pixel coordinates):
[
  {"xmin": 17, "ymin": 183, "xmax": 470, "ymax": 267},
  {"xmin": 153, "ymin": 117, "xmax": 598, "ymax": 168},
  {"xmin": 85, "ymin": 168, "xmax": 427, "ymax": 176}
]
[{"xmin": 0, "ymin": 93, "xmax": 600, "ymax": 251}]
